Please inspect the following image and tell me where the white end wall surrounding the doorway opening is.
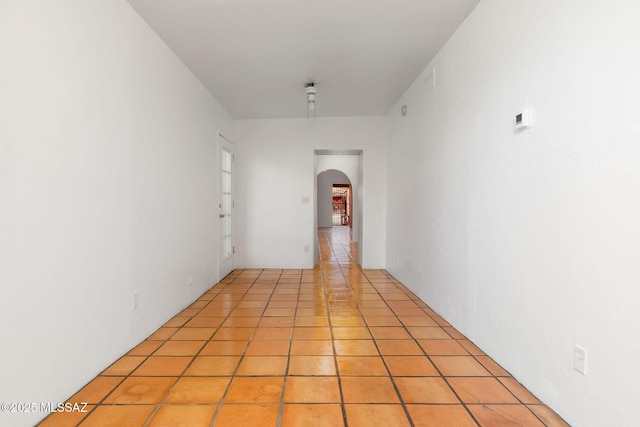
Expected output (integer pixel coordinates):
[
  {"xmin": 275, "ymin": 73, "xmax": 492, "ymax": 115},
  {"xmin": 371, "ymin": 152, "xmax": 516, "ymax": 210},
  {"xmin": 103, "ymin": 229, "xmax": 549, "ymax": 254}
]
[{"xmin": 234, "ymin": 117, "xmax": 388, "ymax": 268}]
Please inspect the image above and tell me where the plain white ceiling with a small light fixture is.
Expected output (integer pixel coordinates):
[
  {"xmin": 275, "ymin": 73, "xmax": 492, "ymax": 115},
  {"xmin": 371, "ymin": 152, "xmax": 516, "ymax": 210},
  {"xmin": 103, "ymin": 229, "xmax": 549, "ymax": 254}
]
[{"xmin": 128, "ymin": 0, "xmax": 479, "ymax": 119}]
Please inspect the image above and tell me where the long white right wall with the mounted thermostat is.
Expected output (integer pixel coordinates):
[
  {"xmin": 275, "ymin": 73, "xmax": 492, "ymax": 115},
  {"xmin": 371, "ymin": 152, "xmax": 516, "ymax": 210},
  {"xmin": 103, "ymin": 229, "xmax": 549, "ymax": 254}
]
[{"xmin": 387, "ymin": 0, "xmax": 640, "ymax": 427}]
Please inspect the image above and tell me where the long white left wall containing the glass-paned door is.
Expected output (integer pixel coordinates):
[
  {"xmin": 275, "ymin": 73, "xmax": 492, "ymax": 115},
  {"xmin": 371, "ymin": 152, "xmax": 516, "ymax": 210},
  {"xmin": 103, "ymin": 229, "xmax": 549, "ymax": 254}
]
[{"xmin": 0, "ymin": 0, "xmax": 232, "ymax": 425}]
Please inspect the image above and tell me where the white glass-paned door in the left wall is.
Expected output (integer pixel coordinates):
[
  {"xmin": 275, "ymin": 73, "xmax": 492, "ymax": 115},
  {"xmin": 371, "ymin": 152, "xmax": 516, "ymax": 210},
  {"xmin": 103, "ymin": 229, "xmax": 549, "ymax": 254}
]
[{"xmin": 218, "ymin": 134, "xmax": 235, "ymax": 280}]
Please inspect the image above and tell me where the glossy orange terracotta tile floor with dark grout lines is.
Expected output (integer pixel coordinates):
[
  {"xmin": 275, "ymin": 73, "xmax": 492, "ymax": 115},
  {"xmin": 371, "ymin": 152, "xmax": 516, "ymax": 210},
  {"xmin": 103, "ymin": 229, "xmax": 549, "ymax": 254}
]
[{"xmin": 40, "ymin": 227, "xmax": 567, "ymax": 427}]
